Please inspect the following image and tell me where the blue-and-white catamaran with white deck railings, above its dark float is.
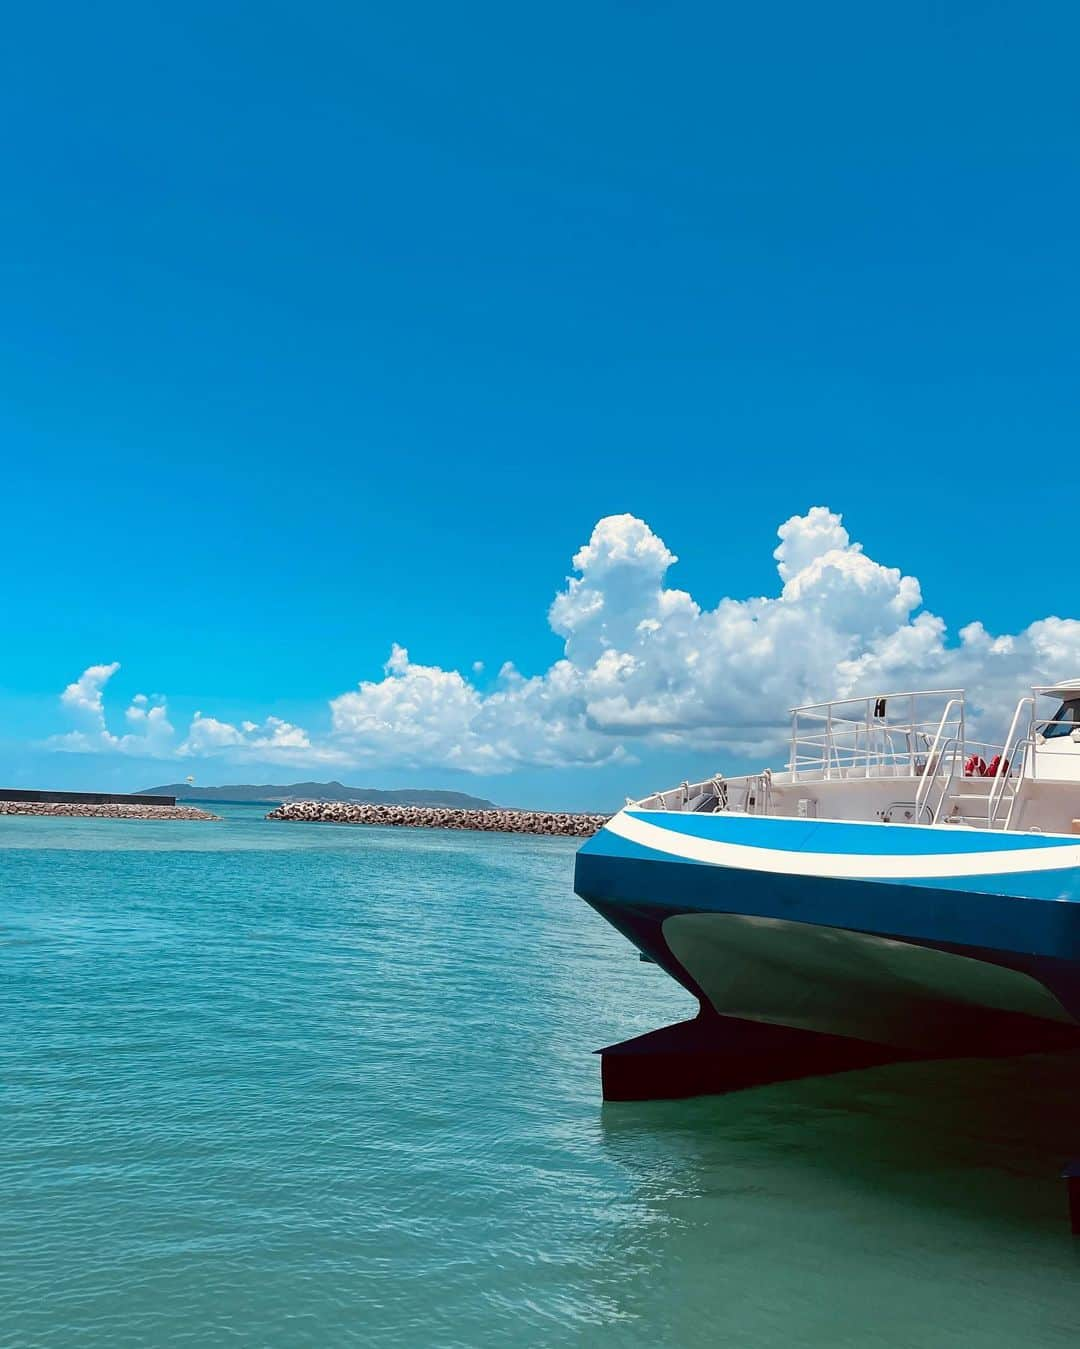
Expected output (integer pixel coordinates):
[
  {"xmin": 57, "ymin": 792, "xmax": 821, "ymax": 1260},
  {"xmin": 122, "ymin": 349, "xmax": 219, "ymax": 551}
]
[{"xmin": 574, "ymin": 680, "xmax": 1080, "ymax": 1094}]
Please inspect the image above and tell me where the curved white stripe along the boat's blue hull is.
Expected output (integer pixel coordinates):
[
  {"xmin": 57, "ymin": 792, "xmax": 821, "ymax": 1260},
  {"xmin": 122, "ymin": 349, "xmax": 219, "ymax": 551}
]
[{"xmin": 605, "ymin": 811, "xmax": 1080, "ymax": 881}]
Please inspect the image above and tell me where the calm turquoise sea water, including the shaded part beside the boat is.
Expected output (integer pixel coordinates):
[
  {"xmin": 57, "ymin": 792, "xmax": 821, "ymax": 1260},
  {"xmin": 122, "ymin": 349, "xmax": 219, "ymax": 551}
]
[{"xmin": 0, "ymin": 808, "xmax": 1080, "ymax": 1349}]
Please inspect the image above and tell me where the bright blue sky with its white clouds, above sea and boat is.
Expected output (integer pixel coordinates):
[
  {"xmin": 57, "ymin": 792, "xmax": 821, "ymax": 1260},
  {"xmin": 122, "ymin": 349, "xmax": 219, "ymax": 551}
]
[{"xmin": 0, "ymin": 4, "xmax": 1080, "ymax": 805}]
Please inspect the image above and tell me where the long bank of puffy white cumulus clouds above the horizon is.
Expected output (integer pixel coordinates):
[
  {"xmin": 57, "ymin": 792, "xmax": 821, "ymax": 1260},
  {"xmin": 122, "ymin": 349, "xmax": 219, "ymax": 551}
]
[{"xmin": 46, "ymin": 506, "xmax": 1080, "ymax": 773}]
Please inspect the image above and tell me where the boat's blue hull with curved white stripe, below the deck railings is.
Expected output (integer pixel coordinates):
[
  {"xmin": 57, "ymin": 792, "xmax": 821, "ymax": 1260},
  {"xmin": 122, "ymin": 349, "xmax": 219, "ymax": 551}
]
[{"xmin": 574, "ymin": 808, "xmax": 1080, "ymax": 1052}]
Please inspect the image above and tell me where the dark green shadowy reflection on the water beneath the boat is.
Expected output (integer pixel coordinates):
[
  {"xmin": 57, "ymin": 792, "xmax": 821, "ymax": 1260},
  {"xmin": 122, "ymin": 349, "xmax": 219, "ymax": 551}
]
[{"xmin": 590, "ymin": 1054, "xmax": 1080, "ymax": 1332}]
